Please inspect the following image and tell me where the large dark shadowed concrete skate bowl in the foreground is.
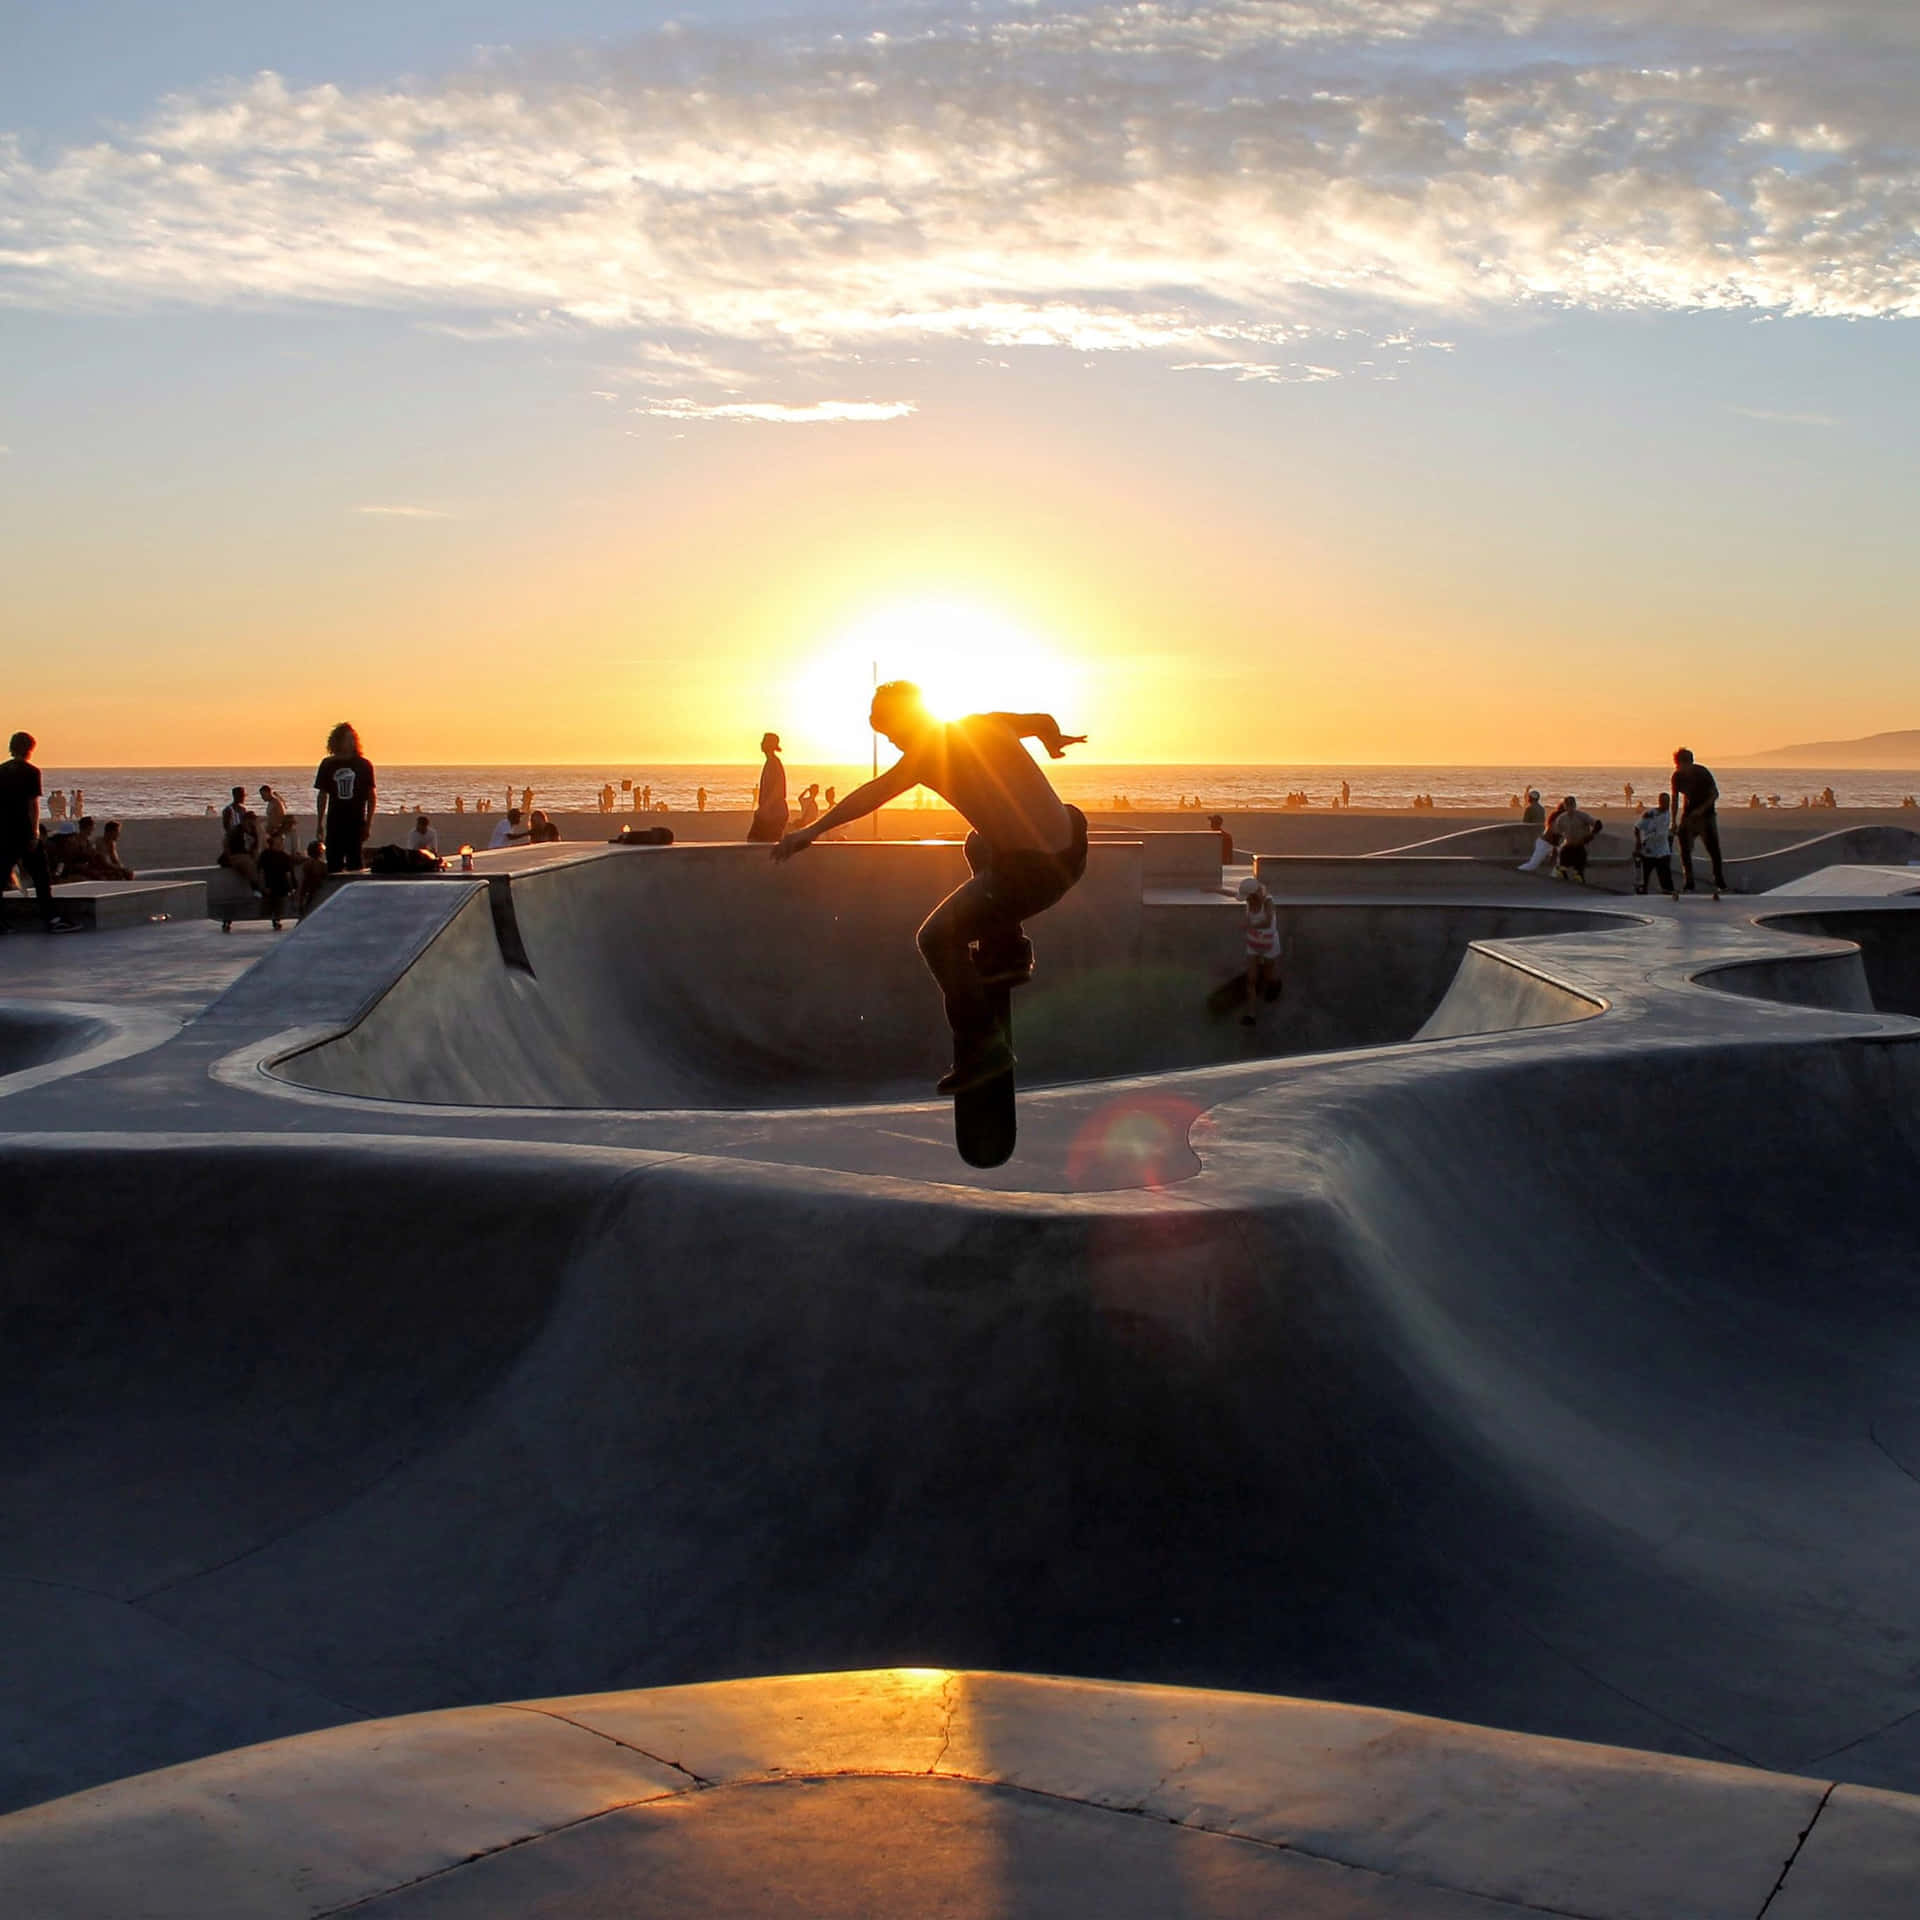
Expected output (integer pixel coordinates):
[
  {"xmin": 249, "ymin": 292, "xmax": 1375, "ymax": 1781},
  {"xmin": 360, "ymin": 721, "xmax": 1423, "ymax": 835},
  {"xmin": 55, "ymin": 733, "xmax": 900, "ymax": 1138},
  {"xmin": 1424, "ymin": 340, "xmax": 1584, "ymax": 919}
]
[{"xmin": 11, "ymin": 1014, "xmax": 1920, "ymax": 1805}]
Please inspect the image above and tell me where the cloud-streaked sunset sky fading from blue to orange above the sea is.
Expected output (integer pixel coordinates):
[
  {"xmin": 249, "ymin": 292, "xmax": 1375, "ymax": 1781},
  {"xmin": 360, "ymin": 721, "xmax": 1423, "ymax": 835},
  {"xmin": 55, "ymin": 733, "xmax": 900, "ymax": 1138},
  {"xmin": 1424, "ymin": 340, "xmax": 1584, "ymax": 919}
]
[{"xmin": 0, "ymin": 0, "xmax": 1920, "ymax": 762}]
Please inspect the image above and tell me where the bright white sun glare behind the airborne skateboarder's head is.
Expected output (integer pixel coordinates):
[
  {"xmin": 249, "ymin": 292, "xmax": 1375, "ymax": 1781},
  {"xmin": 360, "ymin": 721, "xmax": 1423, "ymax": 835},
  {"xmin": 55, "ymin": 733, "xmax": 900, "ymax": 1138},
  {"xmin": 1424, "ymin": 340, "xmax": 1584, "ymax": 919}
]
[{"xmin": 787, "ymin": 599, "xmax": 1081, "ymax": 760}]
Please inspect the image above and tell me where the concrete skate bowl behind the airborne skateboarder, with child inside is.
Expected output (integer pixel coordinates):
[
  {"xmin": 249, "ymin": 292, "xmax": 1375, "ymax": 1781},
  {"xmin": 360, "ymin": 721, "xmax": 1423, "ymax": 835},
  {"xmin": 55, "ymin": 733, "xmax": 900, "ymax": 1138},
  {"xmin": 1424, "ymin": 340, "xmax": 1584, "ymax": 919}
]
[{"xmin": 273, "ymin": 845, "xmax": 1624, "ymax": 1110}]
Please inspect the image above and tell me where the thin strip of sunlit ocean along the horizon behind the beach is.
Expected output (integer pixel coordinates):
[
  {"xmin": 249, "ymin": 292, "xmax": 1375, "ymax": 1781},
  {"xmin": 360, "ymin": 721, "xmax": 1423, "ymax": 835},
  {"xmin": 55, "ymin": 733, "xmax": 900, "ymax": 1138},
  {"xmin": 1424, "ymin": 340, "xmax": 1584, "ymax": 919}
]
[{"xmin": 30, "ymin": 753, "xmax": 1920, "ymax": 820}]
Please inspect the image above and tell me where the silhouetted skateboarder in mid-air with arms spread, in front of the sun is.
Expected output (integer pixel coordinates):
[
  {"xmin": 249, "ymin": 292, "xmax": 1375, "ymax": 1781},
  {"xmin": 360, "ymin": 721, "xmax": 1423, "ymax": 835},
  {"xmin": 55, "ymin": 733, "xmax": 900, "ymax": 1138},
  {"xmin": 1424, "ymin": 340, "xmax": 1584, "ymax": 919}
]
[{"xmin": 774, "ymin": 680, "xmax": 1087, "ymax": 1164}]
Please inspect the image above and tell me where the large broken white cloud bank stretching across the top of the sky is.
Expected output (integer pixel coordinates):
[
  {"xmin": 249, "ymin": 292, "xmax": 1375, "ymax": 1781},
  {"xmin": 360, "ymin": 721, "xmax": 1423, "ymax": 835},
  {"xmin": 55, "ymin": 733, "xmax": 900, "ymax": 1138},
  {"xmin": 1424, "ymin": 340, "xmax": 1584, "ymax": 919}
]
[{"xmin": 0, "ymin": 0, "xmax": 1920, "ymax": 382}]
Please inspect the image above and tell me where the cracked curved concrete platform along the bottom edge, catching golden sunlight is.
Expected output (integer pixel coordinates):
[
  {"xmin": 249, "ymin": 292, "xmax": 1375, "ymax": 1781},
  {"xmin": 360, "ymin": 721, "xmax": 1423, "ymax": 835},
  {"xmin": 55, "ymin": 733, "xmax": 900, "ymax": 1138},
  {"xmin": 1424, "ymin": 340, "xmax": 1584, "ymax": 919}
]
[{"xmin": 0, "ymin": 1668, "xmax": 1920, "ymax": 1920}]
